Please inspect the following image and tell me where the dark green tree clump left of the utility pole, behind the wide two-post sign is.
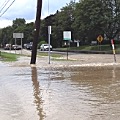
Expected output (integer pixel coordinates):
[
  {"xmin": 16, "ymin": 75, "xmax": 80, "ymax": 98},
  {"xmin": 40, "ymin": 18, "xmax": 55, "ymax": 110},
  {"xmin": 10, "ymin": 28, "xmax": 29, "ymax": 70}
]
[{"xmin": 0, "ymin": 18, "xmax": 34, "ymax": 46}]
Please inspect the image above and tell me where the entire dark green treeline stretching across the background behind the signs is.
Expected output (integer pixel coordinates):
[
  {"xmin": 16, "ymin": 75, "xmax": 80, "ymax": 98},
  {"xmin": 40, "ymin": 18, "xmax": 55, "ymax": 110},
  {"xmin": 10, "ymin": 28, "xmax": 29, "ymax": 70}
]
[{"xmin": 0, "ymin": 0, "xmax": 120, "ymax": 47}]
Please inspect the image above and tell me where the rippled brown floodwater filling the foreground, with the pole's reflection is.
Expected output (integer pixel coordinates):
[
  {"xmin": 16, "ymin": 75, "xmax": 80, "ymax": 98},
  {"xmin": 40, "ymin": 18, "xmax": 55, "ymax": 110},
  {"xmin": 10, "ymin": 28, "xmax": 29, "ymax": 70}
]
[{"xmin": 0, "ymin": 63, "xmax": 120, "ymax": 120}]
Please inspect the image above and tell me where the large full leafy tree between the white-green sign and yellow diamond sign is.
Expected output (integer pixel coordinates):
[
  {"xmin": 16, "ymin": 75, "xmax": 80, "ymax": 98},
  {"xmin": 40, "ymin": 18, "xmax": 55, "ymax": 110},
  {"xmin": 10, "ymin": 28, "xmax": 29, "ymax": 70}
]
[{"xmin": 72, "ymin": 0, "xmax": 103, "ymax": 42}]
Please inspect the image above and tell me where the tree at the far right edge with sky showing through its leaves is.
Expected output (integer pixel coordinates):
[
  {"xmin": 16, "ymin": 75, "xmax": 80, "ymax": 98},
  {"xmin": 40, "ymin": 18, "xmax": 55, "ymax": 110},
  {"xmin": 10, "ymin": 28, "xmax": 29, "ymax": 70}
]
[{"xmin": 100, "ymin": 0, "xmax": 120, "ymax": 39}]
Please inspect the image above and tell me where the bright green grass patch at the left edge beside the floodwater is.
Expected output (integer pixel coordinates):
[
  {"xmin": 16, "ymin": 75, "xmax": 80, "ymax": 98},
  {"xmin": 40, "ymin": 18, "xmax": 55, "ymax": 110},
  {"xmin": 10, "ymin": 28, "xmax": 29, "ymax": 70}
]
[{"xmin": 0, "ymin": 52, "xmax": 18, "ymax": 62}]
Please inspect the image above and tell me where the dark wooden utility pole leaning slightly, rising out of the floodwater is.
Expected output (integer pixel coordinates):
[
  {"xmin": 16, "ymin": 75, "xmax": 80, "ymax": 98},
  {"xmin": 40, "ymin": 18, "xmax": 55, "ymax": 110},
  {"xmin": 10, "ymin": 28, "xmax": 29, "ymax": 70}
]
[{"xmin": 30, "ymin": 0, "xmax": 42, "ymax": 64}]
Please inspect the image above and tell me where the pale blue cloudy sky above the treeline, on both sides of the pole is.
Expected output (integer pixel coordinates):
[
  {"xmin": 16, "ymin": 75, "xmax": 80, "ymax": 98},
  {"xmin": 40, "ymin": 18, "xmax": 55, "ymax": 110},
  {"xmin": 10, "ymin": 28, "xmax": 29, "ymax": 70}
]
[{"xmin": 0, "ymin": 0, "xmax": 79, "ymax": 28}]
